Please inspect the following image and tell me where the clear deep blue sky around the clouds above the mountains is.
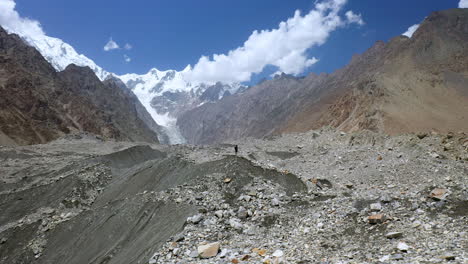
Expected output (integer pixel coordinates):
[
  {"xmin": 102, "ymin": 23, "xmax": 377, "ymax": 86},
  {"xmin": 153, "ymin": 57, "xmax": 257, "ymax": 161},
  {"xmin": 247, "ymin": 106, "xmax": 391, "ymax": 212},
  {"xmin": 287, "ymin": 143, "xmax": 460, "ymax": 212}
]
[{"xmin": 11, "ymin": 0, "xmax": 459, "ymax": 81}]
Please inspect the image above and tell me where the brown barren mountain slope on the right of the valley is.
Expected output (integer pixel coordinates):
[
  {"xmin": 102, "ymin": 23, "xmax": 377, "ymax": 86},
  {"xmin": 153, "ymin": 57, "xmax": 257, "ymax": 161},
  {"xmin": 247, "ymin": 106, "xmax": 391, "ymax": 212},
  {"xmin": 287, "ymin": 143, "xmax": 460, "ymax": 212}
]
[{"xmin": 178, "ymin": 9, "xmax": 468, "ymax": 144}]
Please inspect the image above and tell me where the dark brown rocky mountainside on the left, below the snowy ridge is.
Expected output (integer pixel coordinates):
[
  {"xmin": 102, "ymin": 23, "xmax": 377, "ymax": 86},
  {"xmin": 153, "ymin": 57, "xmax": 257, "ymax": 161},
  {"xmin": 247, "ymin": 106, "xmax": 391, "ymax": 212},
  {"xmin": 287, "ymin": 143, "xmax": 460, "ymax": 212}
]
[{"xmin": 0, "ymin": 28, "xmax": 158, "ymax": 145}]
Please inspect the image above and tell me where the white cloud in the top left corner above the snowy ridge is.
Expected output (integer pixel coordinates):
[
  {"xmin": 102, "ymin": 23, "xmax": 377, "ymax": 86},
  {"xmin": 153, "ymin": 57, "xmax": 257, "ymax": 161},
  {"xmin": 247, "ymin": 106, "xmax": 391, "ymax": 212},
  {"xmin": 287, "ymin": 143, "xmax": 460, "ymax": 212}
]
[{"xmin": 0, "ymin": 0, "xmax": 45, "ymax": 38}]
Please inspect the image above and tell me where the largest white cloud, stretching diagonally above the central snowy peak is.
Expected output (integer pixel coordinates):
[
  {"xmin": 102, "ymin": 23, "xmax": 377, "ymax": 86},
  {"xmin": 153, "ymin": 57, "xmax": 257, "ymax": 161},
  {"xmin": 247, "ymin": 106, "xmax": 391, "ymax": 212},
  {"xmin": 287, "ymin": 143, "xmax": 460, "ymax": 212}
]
[{"xmin": 185, "ymin": 0, "xmax": 364, "ymax": 82}]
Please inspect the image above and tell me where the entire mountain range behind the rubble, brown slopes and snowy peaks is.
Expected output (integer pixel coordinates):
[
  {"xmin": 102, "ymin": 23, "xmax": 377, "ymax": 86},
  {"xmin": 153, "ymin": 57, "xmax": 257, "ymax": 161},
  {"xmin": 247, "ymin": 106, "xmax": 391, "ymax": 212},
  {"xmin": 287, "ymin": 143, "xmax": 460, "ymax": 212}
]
[{"xmin": 0, "ymin": 9, "xmax": 468, "ymax": 144}]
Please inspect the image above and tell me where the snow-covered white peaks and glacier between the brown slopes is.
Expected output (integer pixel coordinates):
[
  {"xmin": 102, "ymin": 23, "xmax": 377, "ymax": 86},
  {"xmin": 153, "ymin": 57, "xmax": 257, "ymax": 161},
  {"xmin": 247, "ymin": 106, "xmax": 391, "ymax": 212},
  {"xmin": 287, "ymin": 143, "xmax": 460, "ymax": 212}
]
[{"xmin": 13, "ymin": 31, "xmax": 243, "ymax": 144}]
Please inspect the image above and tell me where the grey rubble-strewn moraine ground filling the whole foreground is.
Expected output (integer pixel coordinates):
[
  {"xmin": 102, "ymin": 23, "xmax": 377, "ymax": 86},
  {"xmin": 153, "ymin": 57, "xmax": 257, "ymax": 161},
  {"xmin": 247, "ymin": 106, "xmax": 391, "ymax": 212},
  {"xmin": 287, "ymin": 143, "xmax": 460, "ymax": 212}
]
[{"xmin": 0, "ymin": 128, "xmax": 468, "ymax": 263}]
